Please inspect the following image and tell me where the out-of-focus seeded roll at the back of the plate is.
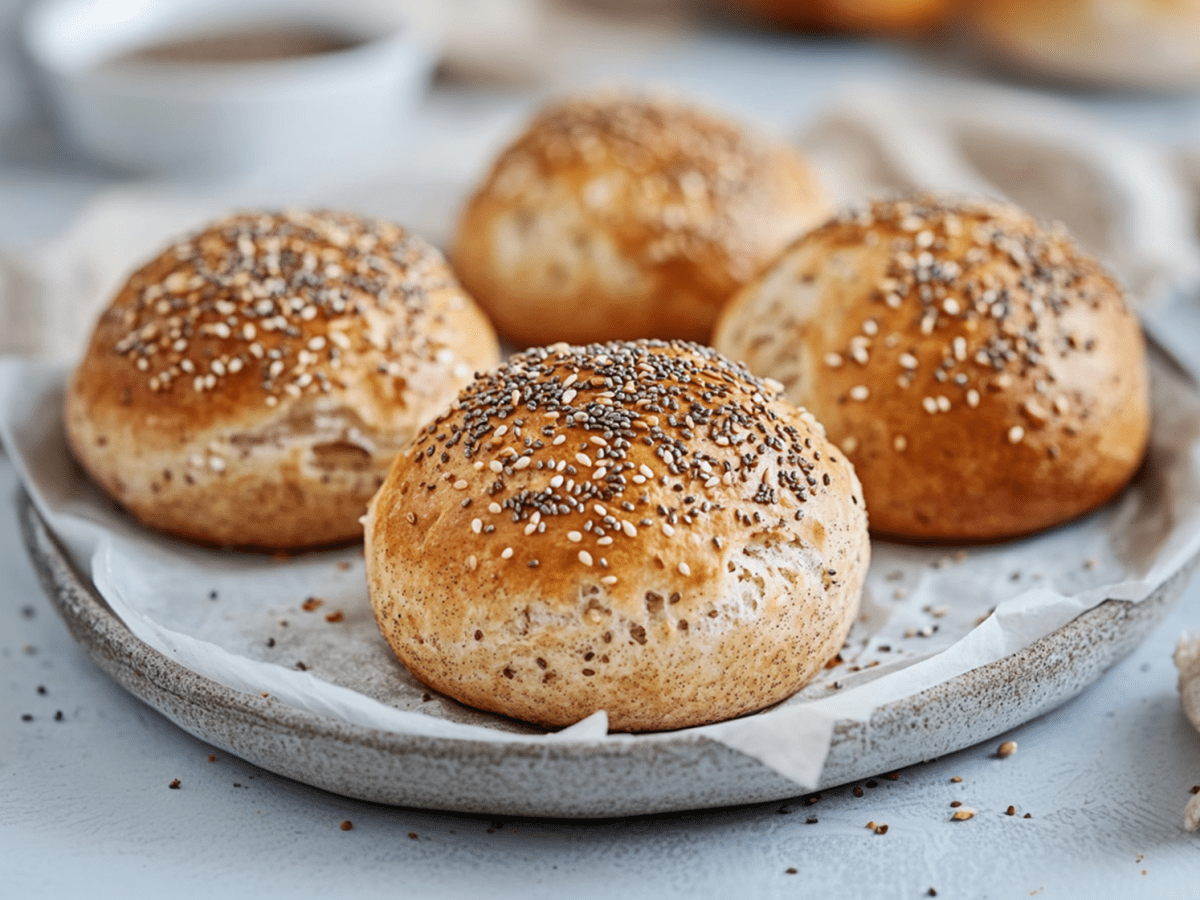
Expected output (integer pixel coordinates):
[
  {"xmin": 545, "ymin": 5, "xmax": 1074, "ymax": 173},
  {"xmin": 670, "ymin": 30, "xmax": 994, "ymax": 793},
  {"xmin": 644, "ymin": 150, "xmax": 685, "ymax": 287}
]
[{"xmin": 454, "ymin": 94, "xmax": 830, "ymax": 346}]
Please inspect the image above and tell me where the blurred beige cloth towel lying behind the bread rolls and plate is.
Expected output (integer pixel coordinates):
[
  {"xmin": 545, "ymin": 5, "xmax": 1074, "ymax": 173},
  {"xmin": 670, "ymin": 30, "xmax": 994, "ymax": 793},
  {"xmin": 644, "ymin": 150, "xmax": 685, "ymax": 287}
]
[{"xmin": 0, "ymin": 82, "xmax": 1200, "ymax": 368}]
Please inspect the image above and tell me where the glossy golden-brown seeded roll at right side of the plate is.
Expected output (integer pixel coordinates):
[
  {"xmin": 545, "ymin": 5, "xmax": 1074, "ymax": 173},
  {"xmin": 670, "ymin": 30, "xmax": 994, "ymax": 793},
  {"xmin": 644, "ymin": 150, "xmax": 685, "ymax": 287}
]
[{"xmin": 713, "ymin": 197, "xmax": 1150, "ymax": 540}]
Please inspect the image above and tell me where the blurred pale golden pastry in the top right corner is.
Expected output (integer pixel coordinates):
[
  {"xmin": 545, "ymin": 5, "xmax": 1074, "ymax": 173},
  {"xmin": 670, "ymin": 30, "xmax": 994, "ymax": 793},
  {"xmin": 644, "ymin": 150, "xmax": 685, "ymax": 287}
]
[{"xmin": 964, "ymin": 0, "xmax": 1200, "ymax": 89}]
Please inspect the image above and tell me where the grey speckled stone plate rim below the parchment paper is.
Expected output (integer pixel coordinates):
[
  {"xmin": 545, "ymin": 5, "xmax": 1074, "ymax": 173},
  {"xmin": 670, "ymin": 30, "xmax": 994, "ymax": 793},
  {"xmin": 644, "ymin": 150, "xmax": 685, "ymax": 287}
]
[{"xmin": 20, "ymin": 494, "xmax": 1196, "ymax": 817}]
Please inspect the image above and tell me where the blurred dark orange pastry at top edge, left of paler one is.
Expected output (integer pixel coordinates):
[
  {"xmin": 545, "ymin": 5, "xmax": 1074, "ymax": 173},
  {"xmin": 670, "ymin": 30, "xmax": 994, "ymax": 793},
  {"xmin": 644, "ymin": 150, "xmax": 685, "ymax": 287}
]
[{"xmin": 720, "ymin": 0, "xmax": 956, "ymax": 32}]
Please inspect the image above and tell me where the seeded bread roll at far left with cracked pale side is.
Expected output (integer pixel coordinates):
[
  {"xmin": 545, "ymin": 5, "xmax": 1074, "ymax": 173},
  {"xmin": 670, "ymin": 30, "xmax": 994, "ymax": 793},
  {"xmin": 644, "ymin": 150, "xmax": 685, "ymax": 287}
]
[{"xmin": 66, "ymin": 212, "xmax": 498, "ymax": 550}]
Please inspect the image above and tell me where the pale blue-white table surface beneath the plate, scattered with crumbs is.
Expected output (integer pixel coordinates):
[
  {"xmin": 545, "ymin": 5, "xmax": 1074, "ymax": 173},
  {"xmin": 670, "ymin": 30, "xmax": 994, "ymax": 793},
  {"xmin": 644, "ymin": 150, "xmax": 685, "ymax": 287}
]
[{"xmin": 0, "ymin": 0, "xmax": 1200, "ymax": 899}]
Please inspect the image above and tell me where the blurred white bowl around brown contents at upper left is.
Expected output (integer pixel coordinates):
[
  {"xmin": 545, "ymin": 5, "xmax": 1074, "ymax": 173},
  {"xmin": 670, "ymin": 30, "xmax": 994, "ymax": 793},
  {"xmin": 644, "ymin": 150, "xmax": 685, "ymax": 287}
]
[{"xmin": 23, "ymin": 0, "xmax": 436, "ymax": 175}]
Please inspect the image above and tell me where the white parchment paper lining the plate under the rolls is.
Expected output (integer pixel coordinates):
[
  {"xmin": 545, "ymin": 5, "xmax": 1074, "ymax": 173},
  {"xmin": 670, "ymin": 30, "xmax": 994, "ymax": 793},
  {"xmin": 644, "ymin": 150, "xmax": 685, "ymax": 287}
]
[{"xmin": 9, "ymin": 359, "xmax": 1200, "ymax": 788}]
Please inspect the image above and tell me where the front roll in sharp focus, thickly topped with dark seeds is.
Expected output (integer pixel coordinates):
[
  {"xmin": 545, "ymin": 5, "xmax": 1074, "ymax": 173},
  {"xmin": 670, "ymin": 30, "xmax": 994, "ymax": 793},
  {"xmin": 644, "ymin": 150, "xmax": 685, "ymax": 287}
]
[{"xmin": 366, "ymin": 342, "xmax": 870, "ymax": 731}]
